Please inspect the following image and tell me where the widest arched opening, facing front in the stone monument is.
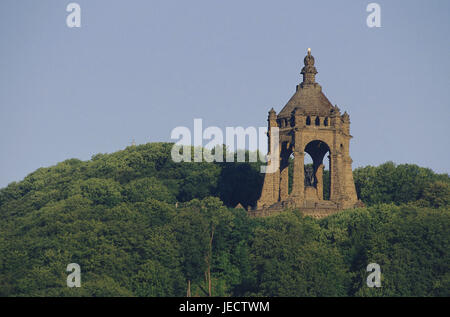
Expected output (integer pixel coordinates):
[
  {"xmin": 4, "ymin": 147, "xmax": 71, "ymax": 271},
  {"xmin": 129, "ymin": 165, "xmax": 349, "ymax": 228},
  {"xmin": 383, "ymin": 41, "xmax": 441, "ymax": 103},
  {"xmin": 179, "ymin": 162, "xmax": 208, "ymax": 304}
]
[{"xmin": 305, "ymin": 140, "xmax": 331, "ymax": 200}]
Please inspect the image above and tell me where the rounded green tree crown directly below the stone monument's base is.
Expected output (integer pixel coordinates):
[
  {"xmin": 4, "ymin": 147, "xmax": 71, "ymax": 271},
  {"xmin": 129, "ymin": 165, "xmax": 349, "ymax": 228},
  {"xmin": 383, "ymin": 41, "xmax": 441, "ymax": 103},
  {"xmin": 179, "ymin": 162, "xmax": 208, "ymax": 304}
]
[{"xmin": 251, "ymin": 213, "xmax": 349, "ymax": 296}]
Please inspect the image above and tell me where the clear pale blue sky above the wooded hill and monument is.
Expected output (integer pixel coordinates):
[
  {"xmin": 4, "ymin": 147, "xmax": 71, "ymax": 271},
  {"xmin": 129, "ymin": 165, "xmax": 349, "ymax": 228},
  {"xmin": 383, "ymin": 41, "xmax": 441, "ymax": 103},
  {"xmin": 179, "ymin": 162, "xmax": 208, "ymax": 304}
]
[{"xmin": 0, "ymin": 0, "xmax": 450, "ymax": 187}]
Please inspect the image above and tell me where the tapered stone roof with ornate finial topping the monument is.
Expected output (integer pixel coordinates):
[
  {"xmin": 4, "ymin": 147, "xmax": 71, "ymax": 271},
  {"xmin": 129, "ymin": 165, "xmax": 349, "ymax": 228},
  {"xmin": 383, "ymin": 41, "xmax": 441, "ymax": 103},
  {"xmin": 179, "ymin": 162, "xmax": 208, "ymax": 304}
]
[{"xmin": 278, "ymin": 49, "xmax": 333, "ymax": 117}]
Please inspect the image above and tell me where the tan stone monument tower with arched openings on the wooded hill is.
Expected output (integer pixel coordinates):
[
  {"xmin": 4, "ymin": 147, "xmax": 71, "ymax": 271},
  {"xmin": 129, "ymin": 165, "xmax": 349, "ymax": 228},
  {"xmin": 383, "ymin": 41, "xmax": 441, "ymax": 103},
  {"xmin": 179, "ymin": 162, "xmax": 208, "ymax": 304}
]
[{"xmin": 253, "ymin": 49, "xmax": 362, "ymax": 217}]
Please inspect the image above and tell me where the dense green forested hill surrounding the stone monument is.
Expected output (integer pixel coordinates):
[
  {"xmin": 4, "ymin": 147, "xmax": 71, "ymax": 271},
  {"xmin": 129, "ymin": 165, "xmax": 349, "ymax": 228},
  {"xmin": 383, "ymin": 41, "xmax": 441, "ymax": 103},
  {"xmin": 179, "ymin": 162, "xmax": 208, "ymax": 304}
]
[{"xmin": 0, "ymin": 143, "xmax": 450, "ymax": 296}]
